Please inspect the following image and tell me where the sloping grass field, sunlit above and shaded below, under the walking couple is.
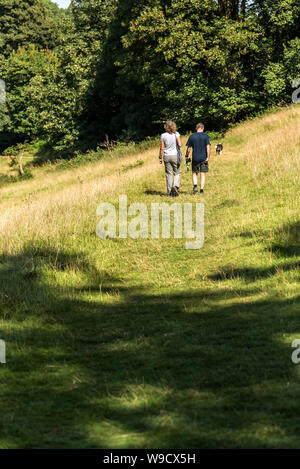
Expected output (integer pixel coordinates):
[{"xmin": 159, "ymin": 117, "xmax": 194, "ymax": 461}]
[{"xmin": 0, "ymin": 106, "xmax": 300, "ymax": 448}]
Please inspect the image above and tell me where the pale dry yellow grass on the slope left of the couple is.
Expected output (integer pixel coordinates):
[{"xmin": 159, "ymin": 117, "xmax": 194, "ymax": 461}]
[{"xmin": 0, "ymin": 150, "xmax": 163, "ymax": 252}]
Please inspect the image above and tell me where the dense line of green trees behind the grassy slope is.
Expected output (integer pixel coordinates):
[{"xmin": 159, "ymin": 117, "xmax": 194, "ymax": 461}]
[{"xmin": 0, "ymin": 0, "xmax": 300, "ymax": 156}]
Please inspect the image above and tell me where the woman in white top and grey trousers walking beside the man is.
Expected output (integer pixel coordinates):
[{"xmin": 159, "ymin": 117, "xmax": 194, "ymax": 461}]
[{"xmin": 159, "ymin": 121, "xmax": 182, "ymax": 196}]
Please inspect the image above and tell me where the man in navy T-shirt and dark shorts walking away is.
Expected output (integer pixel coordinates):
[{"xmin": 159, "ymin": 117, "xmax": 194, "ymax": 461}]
[{"xmin": 185, "ymin": 123, "xmax": 210, "ymax": 195}]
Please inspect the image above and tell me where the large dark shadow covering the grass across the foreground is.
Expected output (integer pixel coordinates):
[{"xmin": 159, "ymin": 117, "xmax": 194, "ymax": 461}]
[{"xmin": 0, "ymin": 234, "xmax": 300, "ymax": 448}]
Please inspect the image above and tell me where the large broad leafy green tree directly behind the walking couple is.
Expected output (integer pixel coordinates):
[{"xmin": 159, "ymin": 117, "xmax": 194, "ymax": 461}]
[{"xmin": 88, "ymin": 0, "xmax": 269, "ymax": 138}]
